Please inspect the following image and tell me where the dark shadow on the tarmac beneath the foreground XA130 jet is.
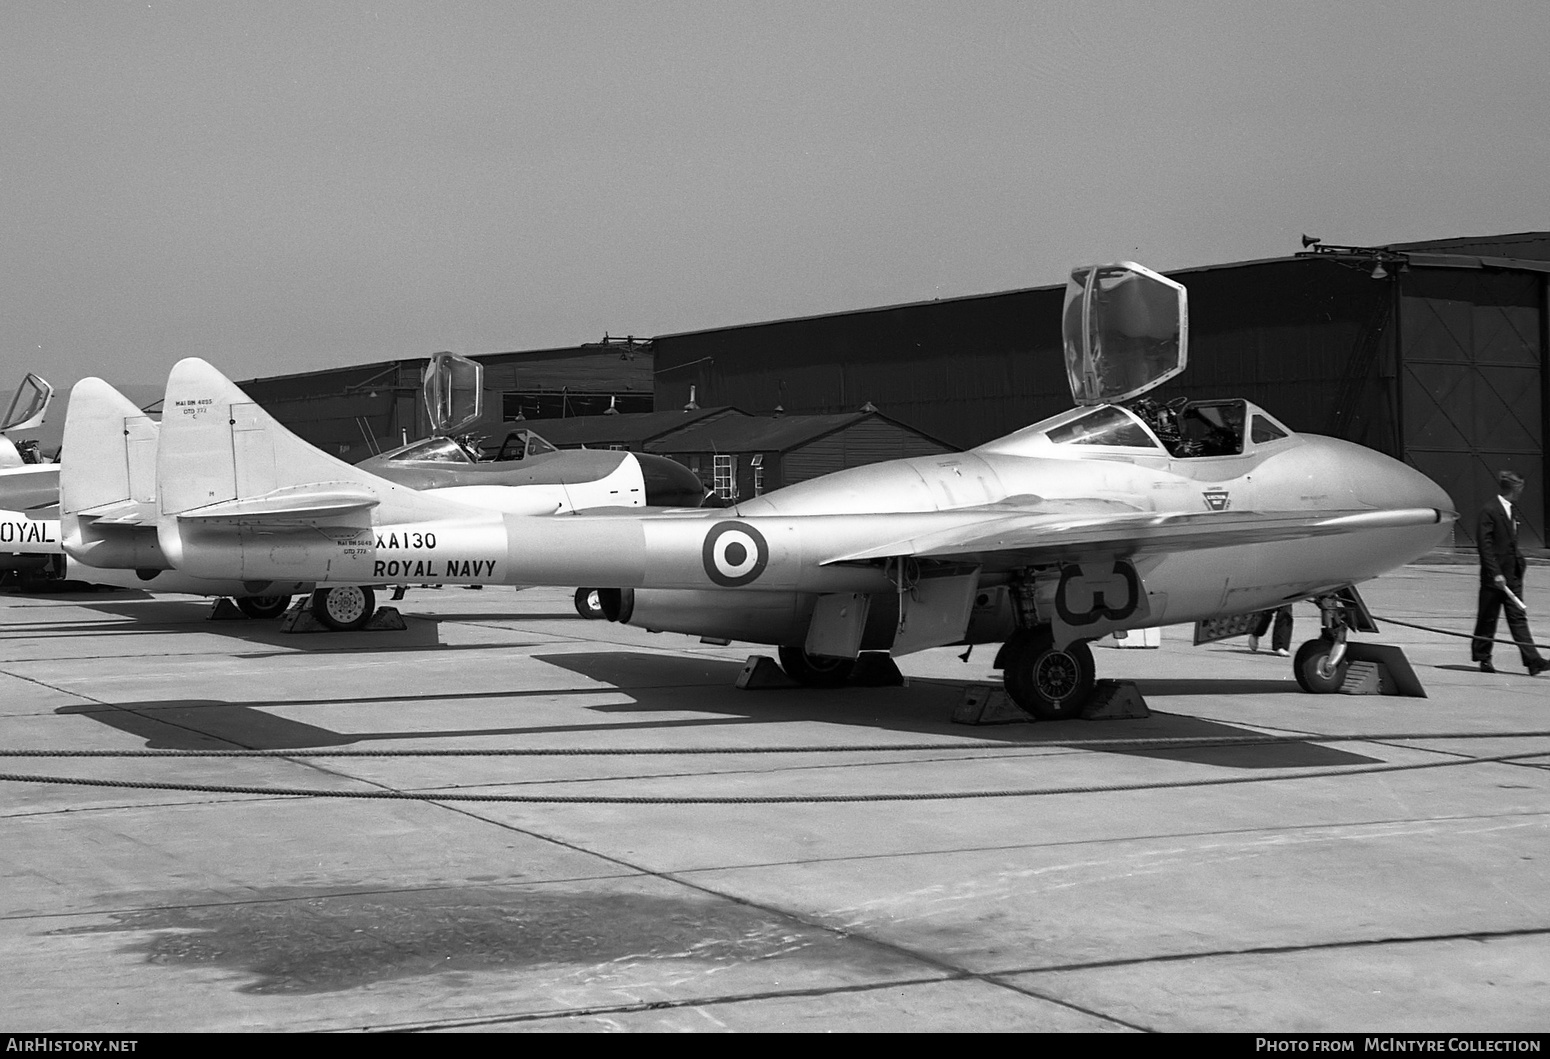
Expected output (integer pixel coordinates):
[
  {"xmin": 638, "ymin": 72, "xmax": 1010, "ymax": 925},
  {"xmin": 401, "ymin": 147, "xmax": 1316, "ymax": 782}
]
[{"xmin": 56, "ymin": 651, "xmax": 1375, "ymax": 769}]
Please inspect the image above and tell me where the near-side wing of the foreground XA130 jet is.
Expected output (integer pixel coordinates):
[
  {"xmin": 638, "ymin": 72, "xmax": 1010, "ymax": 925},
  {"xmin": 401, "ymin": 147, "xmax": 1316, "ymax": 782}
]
[{"xmin": 822, "ymin": 507, "xmax": 1455, "ymax": 567}]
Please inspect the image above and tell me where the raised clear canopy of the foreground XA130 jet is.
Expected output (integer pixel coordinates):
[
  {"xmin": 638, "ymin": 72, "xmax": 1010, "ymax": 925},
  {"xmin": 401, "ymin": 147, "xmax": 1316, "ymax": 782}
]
[{"xmin": 1062, "ymin": 260, "xmax": 1189, "ymax": 405}]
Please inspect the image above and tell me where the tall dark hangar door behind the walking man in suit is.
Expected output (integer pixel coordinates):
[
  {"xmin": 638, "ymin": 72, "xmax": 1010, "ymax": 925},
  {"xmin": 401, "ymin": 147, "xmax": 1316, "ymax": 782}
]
[{"xmin": 1400, "ymin": 268, "xmax": 1545, "ymax": 547}]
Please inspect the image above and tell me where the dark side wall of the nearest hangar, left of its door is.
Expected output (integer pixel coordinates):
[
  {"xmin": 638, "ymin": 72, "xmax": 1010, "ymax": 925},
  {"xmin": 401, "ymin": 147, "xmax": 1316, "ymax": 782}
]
[{"xmin": 653, "ymin": 259, "xmax": 1395, "ymax": 451}]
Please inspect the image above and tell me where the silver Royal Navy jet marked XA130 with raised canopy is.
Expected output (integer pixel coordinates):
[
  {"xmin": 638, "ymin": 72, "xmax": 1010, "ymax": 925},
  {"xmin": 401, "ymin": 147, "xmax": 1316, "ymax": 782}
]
[{"xmin": 124, "ymin": 262, "xmax": 1457, "ymax": 718}]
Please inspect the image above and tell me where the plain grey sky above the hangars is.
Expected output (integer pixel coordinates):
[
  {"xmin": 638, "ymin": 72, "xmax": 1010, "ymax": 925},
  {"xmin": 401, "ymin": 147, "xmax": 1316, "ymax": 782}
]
[{"xmin": 0, "ymin": 0, "xmax": 1550, "ymax": 406}]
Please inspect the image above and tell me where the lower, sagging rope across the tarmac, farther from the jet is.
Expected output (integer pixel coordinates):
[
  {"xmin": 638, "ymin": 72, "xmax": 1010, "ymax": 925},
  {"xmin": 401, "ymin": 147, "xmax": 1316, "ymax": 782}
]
[{"xmin": 0, "ymin": 750, "xmax": 1550, "ymax": 805}]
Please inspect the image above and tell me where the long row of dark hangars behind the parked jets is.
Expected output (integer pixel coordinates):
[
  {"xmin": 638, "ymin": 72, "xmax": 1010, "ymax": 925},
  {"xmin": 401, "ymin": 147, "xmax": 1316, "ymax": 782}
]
[{"xmin": 232, "ymin": 233, "xmax": 1550, "ymax": 549}]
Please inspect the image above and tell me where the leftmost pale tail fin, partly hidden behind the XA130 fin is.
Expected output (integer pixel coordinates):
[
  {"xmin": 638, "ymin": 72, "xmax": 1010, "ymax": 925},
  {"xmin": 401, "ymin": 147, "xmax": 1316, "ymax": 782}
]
[{"xmin": 59, "ymin": 378, "xmax": 167, "ymax": 569}]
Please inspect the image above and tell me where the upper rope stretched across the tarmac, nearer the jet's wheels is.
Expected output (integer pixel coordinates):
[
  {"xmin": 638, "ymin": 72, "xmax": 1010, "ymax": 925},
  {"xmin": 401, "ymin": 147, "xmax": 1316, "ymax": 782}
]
[{"xmin": 9, "ymin": 729, "xmax": 1550, "ymax": 758}]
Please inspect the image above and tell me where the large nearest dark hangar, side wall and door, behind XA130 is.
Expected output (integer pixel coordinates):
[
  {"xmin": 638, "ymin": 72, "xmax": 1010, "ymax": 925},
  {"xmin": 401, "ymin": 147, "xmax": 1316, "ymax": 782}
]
[{"xmin": 653, "ymin": 254, "xmax": 1550, "ymax": 547}]
